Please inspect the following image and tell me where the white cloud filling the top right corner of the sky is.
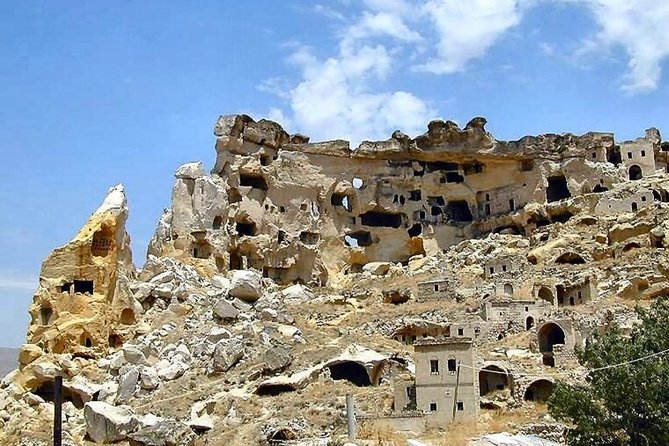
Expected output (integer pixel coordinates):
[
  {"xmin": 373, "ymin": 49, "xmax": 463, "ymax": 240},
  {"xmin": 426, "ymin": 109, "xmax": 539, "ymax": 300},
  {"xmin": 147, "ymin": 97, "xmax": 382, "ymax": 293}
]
[{"xmin": 582, "ymin": 0, "xmax": 669, "ymax": 93}]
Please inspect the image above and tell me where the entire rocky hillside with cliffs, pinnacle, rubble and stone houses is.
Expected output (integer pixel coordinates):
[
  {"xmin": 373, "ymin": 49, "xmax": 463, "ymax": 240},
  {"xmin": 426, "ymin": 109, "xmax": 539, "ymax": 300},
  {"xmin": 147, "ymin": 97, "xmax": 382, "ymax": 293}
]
[{"xmin": 0, "ymin": 115, "xmax": 669, "ymax": 445}]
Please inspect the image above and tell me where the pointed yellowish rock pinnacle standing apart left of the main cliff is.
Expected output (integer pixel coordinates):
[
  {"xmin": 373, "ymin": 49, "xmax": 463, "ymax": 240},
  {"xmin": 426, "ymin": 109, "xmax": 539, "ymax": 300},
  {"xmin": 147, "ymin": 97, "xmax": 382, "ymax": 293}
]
[{"xmin": 20, "ymin": 185, "xmax": 137, "ymax": 387}]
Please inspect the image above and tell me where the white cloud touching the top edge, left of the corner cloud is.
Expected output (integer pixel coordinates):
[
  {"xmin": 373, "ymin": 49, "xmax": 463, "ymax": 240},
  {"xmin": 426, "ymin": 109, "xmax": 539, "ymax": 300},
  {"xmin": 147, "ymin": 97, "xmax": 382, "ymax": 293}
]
[{"xmin": 415, "ymin": 0, "xmax": 528, "ymax": 74}]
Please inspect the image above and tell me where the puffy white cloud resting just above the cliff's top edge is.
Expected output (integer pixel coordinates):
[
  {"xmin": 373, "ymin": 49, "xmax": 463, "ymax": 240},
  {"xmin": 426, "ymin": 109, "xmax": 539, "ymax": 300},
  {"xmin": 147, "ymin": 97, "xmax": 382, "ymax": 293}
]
[{"xmin": 284, "ymin": 45, "xmax": 431, "ymax": 147}]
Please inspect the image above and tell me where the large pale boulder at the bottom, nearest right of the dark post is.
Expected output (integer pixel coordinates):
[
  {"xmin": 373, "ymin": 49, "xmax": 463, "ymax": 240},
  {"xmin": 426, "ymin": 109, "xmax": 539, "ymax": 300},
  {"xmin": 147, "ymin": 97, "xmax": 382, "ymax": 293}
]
[{"xmin": 84, "ymin": 401, "xmax": 137, "ymax": 443}]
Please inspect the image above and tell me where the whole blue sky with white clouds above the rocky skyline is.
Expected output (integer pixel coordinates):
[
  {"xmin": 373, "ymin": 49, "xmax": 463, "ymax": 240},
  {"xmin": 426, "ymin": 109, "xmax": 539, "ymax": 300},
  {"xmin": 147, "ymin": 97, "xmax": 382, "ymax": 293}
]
[{"xmin": 0, "ymin": 0, "xmax": 669, "ymax": 346}]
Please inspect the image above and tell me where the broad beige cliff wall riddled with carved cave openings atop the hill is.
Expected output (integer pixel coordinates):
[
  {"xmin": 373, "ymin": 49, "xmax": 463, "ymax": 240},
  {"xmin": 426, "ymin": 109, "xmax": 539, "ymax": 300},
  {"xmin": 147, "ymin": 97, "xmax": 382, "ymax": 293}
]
[{"xmin": 149, "ymin": 115, "xmax": 664, "ymax": 285}]
